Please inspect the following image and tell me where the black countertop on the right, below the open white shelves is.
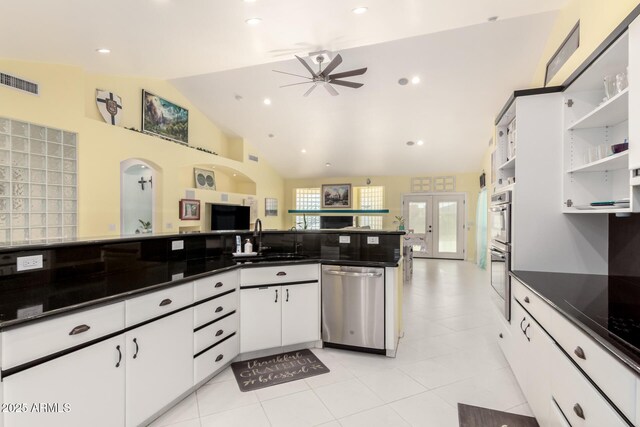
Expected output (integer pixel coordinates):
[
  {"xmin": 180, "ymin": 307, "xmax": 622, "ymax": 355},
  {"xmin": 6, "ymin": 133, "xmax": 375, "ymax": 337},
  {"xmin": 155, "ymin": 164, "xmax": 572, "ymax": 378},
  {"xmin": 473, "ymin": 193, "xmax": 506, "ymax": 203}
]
[{"xmin": 511, "ymin": 271, "xmax": 640, "ymax": 374}]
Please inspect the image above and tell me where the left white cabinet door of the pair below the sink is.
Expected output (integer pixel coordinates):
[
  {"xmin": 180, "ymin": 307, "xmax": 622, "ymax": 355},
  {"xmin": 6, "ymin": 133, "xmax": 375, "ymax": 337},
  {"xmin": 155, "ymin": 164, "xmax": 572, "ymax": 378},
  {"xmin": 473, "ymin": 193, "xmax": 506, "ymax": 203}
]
[{"xmin": 240, "ymin": 286, "xmax": 282, "ymax": 353}]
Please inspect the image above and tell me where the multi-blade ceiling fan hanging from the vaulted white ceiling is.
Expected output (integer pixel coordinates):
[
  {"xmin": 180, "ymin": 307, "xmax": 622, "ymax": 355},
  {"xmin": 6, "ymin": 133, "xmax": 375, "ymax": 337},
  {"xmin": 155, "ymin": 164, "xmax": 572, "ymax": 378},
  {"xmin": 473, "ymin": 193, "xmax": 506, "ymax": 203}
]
[{"xmin": 273, "ymin": 52, "xmax": 367, "ymax": 96}]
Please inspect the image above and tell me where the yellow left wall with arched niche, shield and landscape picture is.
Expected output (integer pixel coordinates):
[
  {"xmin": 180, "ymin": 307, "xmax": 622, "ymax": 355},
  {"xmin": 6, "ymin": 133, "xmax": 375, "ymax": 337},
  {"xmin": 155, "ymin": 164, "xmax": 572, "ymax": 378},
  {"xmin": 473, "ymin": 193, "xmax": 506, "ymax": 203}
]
[{"xmin": 0, "ymin": 59, "xmax": 286, "ymax": 237}]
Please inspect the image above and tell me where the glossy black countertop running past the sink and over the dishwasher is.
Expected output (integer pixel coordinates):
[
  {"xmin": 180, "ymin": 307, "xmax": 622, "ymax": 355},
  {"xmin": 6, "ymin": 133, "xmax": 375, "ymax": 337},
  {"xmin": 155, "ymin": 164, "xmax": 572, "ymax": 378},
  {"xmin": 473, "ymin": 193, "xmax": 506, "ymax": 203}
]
[{"xmin": 0, "ymin": 255, "xmax": 399, "ymax": 331}]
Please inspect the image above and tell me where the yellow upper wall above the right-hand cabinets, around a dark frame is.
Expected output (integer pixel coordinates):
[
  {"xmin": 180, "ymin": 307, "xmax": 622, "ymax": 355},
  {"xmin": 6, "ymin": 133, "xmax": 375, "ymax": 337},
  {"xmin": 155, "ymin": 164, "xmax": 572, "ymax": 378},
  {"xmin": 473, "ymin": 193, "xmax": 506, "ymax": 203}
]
[{"xmin": 528, "ymin": 0, "xmax": 640, "ymax": 89}]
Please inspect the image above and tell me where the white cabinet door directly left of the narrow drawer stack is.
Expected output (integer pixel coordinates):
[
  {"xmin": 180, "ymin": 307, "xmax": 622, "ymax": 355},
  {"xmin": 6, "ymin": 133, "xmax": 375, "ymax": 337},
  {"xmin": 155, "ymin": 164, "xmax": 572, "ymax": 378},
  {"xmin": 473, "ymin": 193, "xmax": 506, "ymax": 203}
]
[{"xmin": 125, "ymin": 308, "xmax": 193, "ymax": 426}]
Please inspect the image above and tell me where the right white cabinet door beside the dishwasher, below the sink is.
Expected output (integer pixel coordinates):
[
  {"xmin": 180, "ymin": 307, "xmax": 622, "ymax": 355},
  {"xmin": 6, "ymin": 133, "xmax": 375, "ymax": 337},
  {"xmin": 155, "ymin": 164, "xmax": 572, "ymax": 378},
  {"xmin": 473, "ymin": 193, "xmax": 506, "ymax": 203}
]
[{"xmin": 282, "ymin": 283, "xmax": 320, "ymax": 346}]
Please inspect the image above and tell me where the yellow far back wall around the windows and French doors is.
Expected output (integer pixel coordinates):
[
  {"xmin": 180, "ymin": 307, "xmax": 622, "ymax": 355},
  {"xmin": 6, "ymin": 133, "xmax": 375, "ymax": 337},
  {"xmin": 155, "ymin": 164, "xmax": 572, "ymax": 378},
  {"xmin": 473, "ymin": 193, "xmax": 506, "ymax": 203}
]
[{"xmin": 284, "ymin": 172, "xmax": 480, "ymax": 260}]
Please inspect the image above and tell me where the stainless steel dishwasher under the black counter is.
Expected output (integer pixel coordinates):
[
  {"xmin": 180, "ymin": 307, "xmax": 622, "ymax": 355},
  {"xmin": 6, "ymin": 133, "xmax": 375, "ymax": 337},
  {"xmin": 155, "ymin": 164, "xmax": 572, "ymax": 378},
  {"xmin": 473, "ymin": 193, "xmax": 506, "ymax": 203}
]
[{"xmin": 322, "ymin": 265, "xmax": 385, "ymax": 354}]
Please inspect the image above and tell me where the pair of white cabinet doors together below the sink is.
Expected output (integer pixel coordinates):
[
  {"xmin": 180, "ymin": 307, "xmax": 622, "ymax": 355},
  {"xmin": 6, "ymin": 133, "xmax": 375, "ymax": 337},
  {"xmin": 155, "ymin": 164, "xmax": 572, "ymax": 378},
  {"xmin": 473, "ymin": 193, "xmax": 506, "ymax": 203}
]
[{"xmin": 240, "ymin": 282, "xmax": 320, "ymax": 353}]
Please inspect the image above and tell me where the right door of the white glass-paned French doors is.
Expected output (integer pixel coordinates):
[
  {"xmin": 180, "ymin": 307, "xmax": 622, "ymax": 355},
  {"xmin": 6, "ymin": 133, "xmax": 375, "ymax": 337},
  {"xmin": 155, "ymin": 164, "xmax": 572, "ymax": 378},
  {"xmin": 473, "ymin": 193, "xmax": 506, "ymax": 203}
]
[{"xmin": 432, "ymin": 194, "xmax": 465, "ymax": 259}]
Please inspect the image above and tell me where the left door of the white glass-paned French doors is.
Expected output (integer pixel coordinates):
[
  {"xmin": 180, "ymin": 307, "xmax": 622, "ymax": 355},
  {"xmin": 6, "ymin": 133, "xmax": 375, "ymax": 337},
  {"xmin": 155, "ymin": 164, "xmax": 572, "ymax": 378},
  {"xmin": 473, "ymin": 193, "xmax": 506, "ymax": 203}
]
[{"xmin": 402, "ymin": 195, "xmax": 433, "ymax": 258}]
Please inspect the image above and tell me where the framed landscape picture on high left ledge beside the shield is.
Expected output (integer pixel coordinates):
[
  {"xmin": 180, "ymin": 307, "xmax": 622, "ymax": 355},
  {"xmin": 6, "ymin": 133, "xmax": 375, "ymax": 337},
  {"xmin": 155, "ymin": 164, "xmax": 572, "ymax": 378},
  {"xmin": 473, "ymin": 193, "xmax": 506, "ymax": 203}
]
[{"xmin": 142, "ymin": 89, "xmax": 189, "ymax": 144}]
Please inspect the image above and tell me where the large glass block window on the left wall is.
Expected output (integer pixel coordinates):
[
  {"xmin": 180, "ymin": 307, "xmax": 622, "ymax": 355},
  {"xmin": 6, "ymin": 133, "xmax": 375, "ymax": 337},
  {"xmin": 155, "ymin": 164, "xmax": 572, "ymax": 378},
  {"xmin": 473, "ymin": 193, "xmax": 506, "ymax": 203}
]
[{"xmin": 0, "ymin": 117, "xmax": 78, "ymax": 245}]
